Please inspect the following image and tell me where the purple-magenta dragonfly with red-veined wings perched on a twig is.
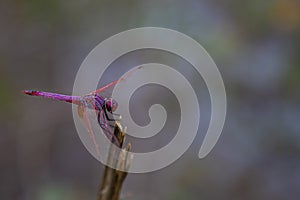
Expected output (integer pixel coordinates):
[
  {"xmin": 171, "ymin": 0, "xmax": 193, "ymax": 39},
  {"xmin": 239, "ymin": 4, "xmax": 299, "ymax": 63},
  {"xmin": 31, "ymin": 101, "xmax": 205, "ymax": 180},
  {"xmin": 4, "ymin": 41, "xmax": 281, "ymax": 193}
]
[{"xmin": 23, "ymin": 67, "xmax": 142, "ymax": 155}]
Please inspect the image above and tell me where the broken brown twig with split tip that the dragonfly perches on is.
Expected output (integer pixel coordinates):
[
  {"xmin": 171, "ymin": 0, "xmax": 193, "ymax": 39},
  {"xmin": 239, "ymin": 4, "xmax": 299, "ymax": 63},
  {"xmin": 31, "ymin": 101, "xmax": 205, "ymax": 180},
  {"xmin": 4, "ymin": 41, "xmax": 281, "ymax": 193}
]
[{"xmin": 97, "ymin": 122, "xmax": 131, "ymax": 200}]
